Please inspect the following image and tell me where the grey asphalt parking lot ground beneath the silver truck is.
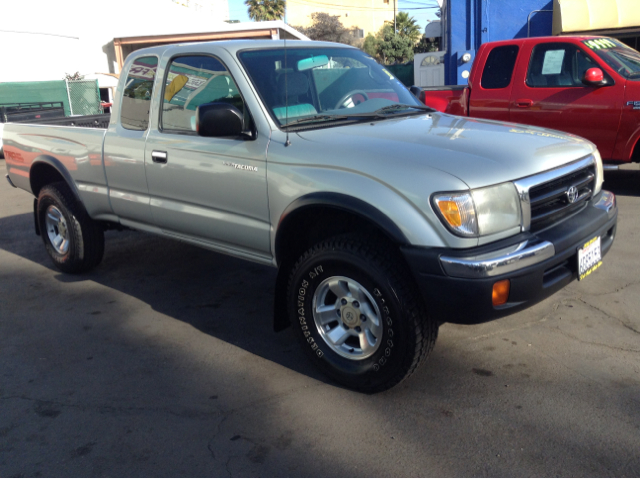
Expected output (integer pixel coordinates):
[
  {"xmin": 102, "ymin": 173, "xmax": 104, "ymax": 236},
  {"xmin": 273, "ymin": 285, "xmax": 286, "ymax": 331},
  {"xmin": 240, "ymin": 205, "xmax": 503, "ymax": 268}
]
[{"xmin": 0, "ymin": 160, "xmax": 640, "ymax": 477}]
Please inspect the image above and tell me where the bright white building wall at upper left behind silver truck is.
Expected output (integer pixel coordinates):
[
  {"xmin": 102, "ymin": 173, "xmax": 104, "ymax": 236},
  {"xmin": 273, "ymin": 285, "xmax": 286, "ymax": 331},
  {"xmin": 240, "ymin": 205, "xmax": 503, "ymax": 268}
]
[{"xmin": 0, "ymin": 0, "xmax": 229, "ymax": 86}]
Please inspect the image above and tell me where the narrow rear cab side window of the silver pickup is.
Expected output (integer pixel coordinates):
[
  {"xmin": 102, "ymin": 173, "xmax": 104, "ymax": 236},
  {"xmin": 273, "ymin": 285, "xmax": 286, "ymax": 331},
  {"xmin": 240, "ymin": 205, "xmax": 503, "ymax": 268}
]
[{"xmin": 120, "ymin": 57, "xmax": 158, "ymax": 131}]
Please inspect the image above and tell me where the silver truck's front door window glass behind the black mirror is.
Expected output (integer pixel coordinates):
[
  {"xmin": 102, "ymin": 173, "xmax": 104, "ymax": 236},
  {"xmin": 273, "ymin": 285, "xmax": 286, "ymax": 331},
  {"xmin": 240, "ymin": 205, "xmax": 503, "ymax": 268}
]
[{"xmin": 160, "ymin": 55, "xmax": 250, "ymax": 134}]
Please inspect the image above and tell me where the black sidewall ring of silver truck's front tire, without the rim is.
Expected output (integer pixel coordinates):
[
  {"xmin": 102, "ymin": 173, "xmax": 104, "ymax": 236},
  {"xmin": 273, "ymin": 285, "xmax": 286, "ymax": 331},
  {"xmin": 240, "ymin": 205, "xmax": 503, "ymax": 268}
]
[{"xmin": 287, "ymin": 249, "xmax": 416, "ymax": 391}]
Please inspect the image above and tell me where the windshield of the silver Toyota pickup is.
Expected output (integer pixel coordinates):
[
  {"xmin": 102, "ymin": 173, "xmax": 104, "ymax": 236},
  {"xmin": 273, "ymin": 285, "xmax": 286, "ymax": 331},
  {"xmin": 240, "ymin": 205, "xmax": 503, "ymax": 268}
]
[{"xmin": 238, "ymin": 47, "xmax": 425, "ymax": 126}]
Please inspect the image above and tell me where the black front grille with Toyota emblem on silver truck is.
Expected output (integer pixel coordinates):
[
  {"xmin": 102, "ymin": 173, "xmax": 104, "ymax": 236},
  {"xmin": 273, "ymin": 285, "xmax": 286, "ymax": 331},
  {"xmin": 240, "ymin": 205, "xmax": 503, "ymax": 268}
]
[{"xmin": 529, "ymin": 164, "xmax": 596, "ymax": 231}]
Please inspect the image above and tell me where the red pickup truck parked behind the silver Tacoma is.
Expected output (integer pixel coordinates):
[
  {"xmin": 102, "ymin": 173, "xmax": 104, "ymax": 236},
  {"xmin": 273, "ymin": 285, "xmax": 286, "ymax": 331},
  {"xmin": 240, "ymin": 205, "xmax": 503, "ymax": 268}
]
[{"xmin": 421, "ymin": 36, "xmax": 640, "ymax": 164}]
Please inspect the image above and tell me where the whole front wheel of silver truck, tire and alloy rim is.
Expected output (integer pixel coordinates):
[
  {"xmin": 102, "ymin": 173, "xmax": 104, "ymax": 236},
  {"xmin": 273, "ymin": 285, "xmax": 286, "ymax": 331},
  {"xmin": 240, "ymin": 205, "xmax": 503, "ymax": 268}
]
[{"xmin": 287, "ymin": 235, "xmax": 438, "ymax": 393}]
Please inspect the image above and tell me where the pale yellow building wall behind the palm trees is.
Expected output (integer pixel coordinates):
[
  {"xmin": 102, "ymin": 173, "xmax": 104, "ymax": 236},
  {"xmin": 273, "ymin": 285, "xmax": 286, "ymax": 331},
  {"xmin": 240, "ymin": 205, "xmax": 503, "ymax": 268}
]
[{"xmin": 286, "ymin": 0, "xmax": 394, "ymax": 37}]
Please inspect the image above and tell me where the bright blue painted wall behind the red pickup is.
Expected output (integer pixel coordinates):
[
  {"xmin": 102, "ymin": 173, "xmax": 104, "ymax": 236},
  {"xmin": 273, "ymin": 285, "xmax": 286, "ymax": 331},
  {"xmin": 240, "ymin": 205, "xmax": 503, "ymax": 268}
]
[{"xmin": 442, "ymin": 0, "xmax": 553, "ymax": 85}]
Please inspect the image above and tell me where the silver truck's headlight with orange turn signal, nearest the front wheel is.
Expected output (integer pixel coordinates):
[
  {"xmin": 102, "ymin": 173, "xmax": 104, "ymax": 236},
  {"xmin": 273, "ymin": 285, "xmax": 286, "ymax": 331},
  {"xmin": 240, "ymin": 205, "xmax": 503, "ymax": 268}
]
[{"xmin": 432, "ymin": 183, "xmax": 521, "ymax": 237}]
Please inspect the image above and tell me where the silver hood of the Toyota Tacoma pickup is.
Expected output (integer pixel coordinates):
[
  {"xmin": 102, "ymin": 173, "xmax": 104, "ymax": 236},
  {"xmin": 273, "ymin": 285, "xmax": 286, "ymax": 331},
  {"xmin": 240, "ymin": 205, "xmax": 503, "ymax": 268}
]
[{"xmin": 298, "ymin": 113, "xmax": 596, "ymax": 188}]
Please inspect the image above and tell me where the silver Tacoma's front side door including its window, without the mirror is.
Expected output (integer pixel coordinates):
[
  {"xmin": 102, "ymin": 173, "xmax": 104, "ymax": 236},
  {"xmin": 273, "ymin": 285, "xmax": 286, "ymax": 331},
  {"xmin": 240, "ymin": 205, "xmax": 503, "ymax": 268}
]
[{"xmin": 145, "ymin": 55, "xmax": 271, "ymax": 260}]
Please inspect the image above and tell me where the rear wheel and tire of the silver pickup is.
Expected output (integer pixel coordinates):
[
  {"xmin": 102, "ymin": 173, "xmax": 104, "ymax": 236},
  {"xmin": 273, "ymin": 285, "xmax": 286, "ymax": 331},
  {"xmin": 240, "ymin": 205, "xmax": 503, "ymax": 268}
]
[{"xmin": 37, "ymin": 182, "xmax": 104, "ymax": 273}]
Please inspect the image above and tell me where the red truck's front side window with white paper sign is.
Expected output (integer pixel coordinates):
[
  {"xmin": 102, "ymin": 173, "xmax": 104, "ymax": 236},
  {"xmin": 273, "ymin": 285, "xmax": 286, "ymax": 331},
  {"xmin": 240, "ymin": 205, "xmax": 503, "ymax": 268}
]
[{"xmin": 526, "ymin": 43, "xmax": 598, "ymax": 88}]
